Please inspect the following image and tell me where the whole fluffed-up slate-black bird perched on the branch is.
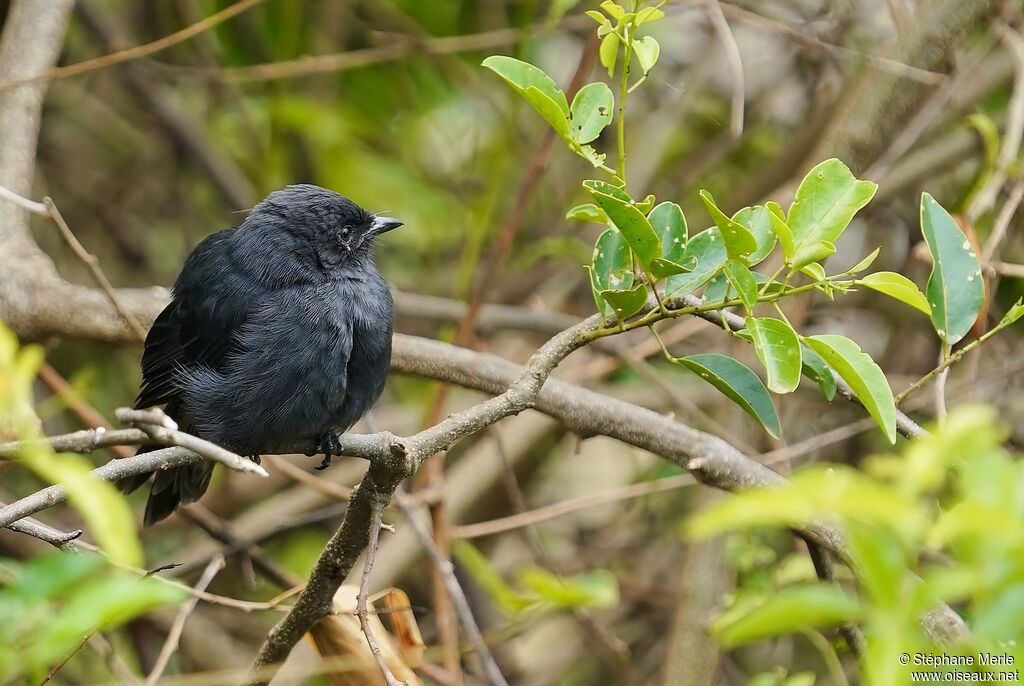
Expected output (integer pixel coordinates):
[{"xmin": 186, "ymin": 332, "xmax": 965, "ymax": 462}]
[{"xmin": 124, "ymin": 185, "xmax": 401, "ymax": 525}]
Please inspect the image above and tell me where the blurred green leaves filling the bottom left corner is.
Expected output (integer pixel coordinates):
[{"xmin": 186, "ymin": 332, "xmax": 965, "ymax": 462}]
[{"xmin": 0, "ymin": 553, "xmax": 184, "ymax": 683}]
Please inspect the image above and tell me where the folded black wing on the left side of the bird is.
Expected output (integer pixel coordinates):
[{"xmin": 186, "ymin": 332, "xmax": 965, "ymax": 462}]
[{"xmin": 135, "ymin": 229, "xmax": 250, "ymax": 408}]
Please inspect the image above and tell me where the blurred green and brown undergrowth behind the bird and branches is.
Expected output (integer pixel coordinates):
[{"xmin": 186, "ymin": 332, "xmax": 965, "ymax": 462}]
[{"xmin": 0, "ymin": 0, "xmax": 1024, "ymax": 685}]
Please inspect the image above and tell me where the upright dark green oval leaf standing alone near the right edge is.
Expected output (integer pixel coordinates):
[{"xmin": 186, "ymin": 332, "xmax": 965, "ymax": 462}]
[{"xmin": 921, "ymin": 192, "xmax": 985, "ymax": 345}]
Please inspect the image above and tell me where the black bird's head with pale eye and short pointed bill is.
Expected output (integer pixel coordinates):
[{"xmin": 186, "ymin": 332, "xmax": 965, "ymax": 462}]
[{"xmin": 239, "ymin": 183, "xmax": 401, "ymax": 278}]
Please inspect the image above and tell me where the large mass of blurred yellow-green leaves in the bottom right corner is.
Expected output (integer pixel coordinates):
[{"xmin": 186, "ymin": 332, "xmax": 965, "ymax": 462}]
[{"xmin": 688, "ymin": 405, "xmax": 1024, "ymax": 686}]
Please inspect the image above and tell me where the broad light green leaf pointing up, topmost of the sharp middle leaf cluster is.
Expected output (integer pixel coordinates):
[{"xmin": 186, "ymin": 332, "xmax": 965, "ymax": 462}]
[{"xmin": 786, "ymin": 158, "xmax": 878, "ymax": 254}]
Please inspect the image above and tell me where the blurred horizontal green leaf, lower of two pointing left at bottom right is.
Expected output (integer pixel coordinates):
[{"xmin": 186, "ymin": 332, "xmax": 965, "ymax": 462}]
[{"xmin": 713, "ymin": 584, "xmax": 859, "ymax": 647}]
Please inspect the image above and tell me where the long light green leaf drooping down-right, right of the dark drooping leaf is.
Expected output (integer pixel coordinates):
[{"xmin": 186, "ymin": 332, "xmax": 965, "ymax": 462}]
[{"xmin": 804, "ymin": 335, "xmax": 896, "ymax": 443}]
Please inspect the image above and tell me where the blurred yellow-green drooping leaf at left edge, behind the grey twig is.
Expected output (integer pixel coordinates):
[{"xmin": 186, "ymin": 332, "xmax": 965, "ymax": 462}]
[{"xmin": 0, "ymin": 323, "xmax": 142, "ymax": 565}]
